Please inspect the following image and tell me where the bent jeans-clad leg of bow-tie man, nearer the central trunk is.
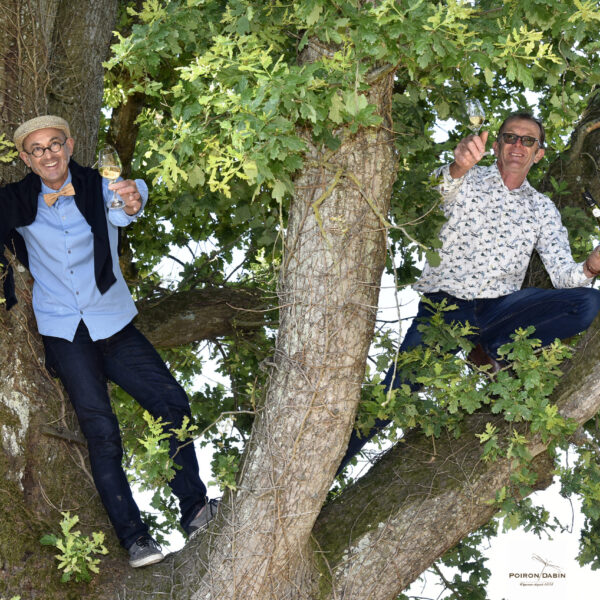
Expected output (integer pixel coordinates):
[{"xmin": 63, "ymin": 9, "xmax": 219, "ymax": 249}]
[{"xmin": 97, "ymin": 324, "xmax": 206, "ymax": 529}]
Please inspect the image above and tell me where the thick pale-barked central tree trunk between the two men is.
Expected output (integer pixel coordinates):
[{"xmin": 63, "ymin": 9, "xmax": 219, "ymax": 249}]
[{"xmin": 182, "ymin": 68, "xmax": 396, "ymax": 600}]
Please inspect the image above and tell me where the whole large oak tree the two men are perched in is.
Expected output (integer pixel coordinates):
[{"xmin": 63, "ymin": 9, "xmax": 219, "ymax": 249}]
[{"xmin": 0, "ymin": 0, "xmax": 600, "ymax": 600}]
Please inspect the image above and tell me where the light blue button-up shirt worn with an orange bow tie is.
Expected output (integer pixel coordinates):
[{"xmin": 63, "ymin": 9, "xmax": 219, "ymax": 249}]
[{"xmin": 17, "ymin": 173, "xmax": 148, "ymax": 341}]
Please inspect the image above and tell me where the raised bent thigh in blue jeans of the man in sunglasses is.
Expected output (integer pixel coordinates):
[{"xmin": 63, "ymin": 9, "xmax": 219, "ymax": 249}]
[{"xmin": 476, "ymin": 288, "xmax": 600, "ymax": 357}]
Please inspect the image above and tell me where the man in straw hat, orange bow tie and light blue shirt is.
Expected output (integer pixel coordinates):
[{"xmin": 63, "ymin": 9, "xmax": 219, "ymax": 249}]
[{"xmin": 0, "ymin": 116, "xmax": 217, "ymax": 567}]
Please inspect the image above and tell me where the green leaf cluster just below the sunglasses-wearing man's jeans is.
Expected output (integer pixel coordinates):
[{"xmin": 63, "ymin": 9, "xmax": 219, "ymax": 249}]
[{"xmin": 358, "ymin": 301, "xmax": 574, "ymax": 454}]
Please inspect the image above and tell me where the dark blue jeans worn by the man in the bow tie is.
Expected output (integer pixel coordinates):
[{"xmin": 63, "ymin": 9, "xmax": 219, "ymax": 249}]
[{"xmin": 42, "ymin": 321, "xmax": 206, "ymax": 548}]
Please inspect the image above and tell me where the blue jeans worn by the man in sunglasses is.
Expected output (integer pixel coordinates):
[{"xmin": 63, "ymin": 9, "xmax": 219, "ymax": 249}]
[{"xmin": 337, "ymin": 287, "xmax": 600, "ymax": 474}]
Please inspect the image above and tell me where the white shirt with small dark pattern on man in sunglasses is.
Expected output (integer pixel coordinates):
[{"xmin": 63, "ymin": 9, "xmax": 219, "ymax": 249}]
[{"xmin": 414, "ymin": 164, "xmax": 592, "ymax": 300}]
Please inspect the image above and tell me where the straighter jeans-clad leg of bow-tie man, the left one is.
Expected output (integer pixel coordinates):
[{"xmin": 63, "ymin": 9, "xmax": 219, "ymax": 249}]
[{"xmin": 43, "ymin": 322, "xmax": 148, "ymax": 548}]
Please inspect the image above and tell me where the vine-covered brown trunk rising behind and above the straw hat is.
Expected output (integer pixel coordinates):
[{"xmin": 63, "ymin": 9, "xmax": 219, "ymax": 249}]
[{"xmin": 0, "ymin": 0, "xmax": 117, "ymax": 176}]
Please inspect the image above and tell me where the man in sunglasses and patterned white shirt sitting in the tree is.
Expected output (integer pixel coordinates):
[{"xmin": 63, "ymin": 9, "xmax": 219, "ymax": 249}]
[{"xmin": 338, "ymin": 112, "xmax": 600, "ymax": 473}]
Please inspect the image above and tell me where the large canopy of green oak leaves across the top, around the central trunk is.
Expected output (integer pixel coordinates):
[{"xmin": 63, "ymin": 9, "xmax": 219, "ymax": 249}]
[{"xmin": 106, "ymin": 0, "xmax": 598, "ymax": 292}]
